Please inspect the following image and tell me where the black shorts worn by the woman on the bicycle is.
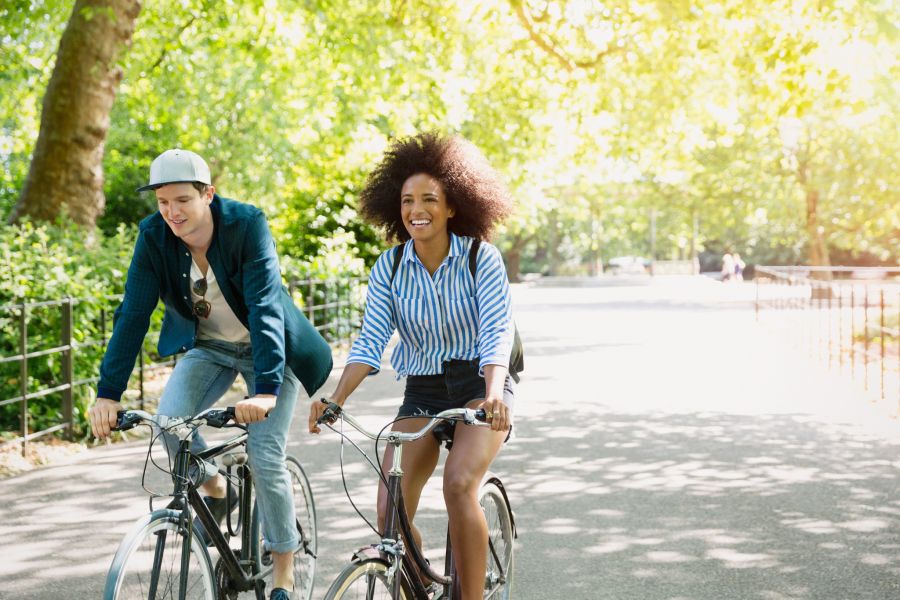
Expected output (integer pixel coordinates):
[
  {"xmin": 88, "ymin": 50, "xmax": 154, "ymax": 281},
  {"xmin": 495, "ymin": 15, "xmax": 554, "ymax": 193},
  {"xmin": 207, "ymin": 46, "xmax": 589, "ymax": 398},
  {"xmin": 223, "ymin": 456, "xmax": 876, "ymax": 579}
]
[{"xmin": 397, "ymin": 359, "xmax": 515, "ymax": 417}]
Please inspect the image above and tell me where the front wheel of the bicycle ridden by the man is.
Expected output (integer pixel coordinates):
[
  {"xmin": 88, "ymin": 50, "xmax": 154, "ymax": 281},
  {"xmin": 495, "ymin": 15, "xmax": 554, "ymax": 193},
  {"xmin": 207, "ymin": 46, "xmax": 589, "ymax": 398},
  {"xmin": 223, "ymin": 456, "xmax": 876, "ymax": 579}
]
[{"xmin": 103, "ymin": 510, "xmax": 216, "ymax": 600}]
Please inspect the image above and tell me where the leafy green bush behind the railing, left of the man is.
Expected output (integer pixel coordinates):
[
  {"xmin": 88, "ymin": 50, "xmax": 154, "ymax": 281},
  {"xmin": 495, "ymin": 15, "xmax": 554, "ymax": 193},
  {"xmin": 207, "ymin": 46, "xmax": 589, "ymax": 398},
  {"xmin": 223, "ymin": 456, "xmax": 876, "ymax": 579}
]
[{"xmin": 0, "ymin": 222, "xmax": 144, "ymax": 433}]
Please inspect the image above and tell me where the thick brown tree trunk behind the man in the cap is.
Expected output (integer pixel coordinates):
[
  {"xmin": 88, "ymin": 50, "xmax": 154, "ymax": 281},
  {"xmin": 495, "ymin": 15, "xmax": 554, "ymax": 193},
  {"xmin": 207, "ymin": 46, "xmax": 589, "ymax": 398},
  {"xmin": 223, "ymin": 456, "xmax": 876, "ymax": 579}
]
[{"xmin": 10, "ymin": 0, "xmax": 141, "ymax": 228}]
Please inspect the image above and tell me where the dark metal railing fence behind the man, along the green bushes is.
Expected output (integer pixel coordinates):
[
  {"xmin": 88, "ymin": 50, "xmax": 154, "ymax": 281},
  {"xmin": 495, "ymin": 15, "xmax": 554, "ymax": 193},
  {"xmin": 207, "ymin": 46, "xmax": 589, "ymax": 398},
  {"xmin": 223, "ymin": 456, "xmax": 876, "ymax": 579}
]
[{"xmin": 0, "ymin": 277, "xmax": 367, "ymax": 455}]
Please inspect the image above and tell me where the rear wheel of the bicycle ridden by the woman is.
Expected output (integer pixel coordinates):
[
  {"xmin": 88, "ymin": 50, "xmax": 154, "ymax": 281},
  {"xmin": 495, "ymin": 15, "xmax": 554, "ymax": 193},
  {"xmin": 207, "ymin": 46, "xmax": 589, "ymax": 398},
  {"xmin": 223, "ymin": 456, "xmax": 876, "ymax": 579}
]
[{"xmin": 478, "ymin": 478, "xmax": 515, "ymax": 600}]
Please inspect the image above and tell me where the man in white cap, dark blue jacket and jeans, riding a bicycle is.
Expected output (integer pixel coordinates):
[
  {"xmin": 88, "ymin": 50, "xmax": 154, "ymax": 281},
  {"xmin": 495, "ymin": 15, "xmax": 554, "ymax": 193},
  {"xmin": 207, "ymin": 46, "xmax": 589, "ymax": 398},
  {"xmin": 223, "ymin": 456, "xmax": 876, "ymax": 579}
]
[{"xmin": 90, "ymin": 150, "xmax": 331, "ymax": 600}]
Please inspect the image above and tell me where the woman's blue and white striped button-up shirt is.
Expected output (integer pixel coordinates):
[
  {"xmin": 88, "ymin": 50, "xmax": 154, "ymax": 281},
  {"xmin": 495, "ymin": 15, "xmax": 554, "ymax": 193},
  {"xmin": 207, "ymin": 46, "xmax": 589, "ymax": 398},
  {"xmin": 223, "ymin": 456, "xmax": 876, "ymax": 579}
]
[{"xmin": 347, "ymin": 233, "xmax": 513, "ymax": 377}]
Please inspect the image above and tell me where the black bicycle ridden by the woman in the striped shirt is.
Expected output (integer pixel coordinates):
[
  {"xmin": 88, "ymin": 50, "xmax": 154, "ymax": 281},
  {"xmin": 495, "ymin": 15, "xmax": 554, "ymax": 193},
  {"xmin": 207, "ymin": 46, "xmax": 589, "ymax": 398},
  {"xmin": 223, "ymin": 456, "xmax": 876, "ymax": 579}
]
[{"xmin": 319, "ymin": 402, "xmax": 516, "ymax": 600}]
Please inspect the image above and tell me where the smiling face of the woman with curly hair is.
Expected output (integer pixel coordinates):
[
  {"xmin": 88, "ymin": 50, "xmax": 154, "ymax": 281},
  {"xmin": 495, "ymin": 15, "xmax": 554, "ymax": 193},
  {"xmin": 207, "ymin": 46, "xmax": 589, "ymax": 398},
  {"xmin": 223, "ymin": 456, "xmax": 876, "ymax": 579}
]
[{"xmin": 400, "ymin": 173, "xmax": 456, "ymax": 242}]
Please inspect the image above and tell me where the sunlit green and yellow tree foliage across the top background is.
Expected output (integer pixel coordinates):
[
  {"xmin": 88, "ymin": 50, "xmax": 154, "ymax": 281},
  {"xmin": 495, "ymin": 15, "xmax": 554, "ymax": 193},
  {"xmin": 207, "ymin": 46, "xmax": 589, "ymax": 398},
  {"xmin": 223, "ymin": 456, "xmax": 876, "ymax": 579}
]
[{"xmin": 0, "ymin": 0, "xmax": 900, "ymax": 270}]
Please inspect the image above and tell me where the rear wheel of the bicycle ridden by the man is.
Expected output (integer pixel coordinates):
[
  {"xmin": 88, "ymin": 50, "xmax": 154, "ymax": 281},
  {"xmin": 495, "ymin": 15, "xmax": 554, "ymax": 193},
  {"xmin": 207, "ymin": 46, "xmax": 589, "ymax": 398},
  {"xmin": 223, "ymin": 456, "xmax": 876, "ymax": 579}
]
[{"xmin": 251, "ymin": 456, "xmax": 319, "ymax": 600}]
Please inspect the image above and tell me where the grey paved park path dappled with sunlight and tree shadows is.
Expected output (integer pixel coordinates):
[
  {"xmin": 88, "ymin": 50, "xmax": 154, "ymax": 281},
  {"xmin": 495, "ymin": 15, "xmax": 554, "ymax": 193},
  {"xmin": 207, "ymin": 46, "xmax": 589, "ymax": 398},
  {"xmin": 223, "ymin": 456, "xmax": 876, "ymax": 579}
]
[{"xmin": 0, "ymin": 278, "xmax": 900, "ymax": 600}]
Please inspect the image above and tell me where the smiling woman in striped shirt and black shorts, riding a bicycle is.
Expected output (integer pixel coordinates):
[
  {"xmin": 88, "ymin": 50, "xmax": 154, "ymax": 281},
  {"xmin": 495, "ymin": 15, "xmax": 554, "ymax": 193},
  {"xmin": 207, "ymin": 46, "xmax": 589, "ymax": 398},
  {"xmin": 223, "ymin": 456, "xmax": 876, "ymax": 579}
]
[{"xmin": 309, "ymin": 133, "xmax": 514, "ymax": 599}]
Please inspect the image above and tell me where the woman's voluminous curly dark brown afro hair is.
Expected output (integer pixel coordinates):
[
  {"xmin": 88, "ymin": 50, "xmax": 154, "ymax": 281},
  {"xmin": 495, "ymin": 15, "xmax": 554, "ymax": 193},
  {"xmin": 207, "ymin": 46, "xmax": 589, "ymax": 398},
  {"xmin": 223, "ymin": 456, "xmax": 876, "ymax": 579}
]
[{"xmin": 360, "ymin": 133, "xmax": 512, "ymax": 242}]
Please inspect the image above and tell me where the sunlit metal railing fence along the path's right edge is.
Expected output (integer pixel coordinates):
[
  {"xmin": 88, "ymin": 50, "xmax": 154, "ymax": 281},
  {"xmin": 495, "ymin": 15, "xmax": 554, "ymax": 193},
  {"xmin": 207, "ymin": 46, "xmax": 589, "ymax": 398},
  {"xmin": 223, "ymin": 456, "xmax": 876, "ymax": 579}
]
[{"xmin": 754, "ymin": 266, "xmax": 900, "ymax": 409}]
